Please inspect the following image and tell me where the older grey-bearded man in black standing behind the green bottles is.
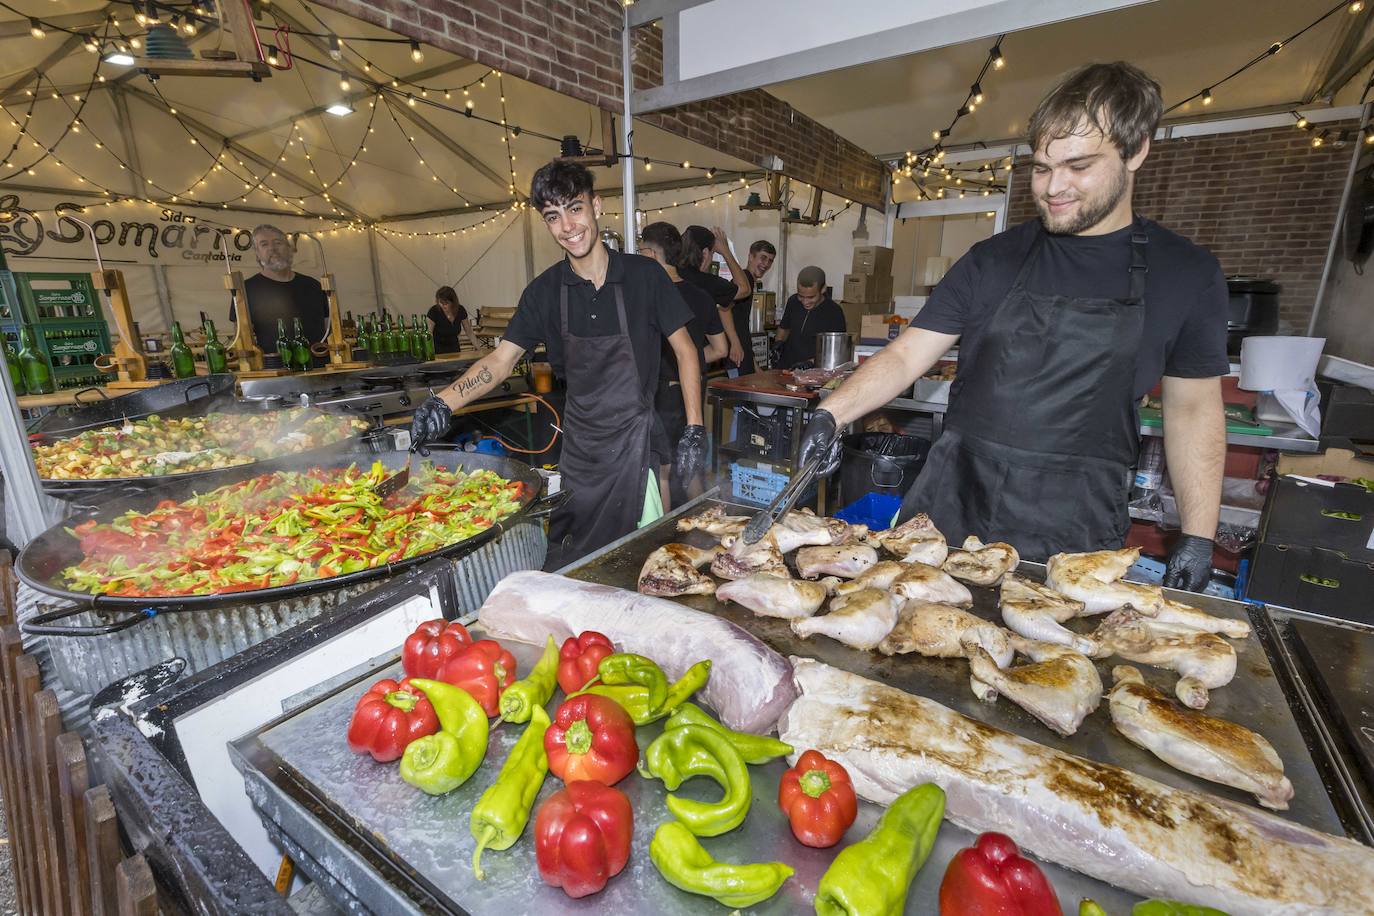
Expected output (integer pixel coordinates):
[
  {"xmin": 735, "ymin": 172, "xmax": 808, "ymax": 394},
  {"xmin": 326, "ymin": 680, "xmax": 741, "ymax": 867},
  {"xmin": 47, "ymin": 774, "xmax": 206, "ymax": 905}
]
[{"xmin": 229, "ymin": 224, "xmax": 330, "ymax": 350}]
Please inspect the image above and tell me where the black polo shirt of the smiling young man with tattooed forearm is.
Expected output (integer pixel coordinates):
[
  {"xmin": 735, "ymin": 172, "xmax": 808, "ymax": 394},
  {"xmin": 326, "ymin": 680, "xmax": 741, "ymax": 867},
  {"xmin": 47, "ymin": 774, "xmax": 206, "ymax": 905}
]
[{"xmin": 502, "ymin": 249, "xmax": 692, "ymax": 394}]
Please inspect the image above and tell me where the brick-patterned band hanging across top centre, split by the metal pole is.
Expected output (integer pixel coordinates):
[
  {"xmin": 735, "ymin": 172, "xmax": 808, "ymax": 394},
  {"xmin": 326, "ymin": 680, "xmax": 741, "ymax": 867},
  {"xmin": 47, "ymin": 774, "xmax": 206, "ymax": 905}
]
[{"xmin": 310, "ymin": 0, "xmax": 885, "ymax": 206}]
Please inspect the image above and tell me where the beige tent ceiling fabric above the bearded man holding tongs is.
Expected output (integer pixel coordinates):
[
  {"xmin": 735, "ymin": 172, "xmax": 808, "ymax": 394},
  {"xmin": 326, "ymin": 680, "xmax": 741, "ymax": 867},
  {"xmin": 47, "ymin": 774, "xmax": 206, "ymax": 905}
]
[{"xmin": 765, "ymin": 0, "xmax": 1367, "ymax": 155}]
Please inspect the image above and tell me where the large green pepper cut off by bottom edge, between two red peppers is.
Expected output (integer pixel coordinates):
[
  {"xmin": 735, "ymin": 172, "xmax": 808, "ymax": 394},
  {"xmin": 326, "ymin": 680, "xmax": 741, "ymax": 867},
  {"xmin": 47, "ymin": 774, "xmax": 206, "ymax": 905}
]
[{"xmin": 816, "ymin": 783, "xmax": 944, "ymax": 916}]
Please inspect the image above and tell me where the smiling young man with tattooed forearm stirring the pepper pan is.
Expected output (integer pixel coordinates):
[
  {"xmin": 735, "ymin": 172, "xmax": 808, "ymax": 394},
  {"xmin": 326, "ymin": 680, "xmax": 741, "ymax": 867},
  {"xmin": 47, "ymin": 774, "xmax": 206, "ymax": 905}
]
[{"xmin": 411, "ymin": 159, "xmax": 706, "ymax": 570}]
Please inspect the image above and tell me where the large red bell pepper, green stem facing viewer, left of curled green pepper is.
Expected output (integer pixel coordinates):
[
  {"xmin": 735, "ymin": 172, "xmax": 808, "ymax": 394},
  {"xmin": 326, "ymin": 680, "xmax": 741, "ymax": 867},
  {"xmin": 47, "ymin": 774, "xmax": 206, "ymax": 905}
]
[{"xmin": 544, "ymin": 694, "xmax": 639, "ymax": 786}]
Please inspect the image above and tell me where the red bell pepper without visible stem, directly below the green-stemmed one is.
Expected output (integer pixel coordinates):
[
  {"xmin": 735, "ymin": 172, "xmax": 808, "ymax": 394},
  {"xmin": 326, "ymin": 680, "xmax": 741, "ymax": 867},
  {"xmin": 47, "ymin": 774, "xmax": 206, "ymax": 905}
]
[{"xmin": 534, "ymin": 781, "xmax": 635, "ymax": 897}]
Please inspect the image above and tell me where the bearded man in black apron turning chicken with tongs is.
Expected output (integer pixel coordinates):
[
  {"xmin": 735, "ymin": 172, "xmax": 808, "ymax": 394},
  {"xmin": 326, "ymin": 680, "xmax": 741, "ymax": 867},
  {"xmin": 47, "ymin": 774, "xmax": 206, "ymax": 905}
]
[{"xmin": 802, "ymin": 63, "xmax": 1228, "ymax": 591}]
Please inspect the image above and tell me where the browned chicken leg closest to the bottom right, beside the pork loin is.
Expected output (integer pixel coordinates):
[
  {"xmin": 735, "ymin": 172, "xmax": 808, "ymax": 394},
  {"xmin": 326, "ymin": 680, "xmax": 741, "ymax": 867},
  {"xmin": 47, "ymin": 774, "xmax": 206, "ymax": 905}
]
[{"xmin": 1107, "ymin": 665, "xmax": 1293, "ymax": 812}]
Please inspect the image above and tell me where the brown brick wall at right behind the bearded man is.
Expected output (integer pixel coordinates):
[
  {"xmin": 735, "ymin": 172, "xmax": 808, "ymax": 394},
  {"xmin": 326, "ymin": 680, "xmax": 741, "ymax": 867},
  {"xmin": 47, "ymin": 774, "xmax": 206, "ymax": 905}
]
[{"xmin": 1007, "ymin": 122, "xmax": 1353, "ymax": 334}]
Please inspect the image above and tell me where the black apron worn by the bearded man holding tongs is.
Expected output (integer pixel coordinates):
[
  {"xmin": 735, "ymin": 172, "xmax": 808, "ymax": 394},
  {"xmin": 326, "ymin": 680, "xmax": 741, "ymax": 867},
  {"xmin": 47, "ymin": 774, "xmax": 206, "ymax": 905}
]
[{"xmin": 899, "ymin": 222, "xmax": 1146, "ymax": 560}]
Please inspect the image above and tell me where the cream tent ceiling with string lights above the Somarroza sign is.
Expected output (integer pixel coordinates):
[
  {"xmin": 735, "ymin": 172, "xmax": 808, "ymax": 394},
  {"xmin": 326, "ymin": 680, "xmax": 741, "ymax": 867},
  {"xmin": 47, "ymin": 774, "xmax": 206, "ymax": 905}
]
[{"xmin": 0, "ymin": 0, "xmax": 750, "ymax": 218}]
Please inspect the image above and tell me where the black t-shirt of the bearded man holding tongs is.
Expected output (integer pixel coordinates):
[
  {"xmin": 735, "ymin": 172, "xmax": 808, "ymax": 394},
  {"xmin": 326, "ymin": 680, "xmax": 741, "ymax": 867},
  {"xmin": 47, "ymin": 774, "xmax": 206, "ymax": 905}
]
[{"xmin": 911, "ymin": 218, "xmax": 1230, "ymax": 397}]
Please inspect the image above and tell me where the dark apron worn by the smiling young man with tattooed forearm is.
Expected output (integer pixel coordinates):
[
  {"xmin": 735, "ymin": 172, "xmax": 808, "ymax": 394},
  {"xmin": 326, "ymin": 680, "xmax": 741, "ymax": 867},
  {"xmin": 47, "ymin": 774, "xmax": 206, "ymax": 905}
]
[{"xmin": 544, "ymin": 283, "xmax": 654, "ymax": 570}]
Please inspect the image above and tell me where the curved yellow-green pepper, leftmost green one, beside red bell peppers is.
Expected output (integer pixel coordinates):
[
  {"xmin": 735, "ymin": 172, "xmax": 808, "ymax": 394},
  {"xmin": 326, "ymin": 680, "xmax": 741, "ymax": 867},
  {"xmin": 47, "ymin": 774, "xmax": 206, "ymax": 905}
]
[{"xmin": 401, "ymin": 677, "xmax": 488, "ymax": 795}]
